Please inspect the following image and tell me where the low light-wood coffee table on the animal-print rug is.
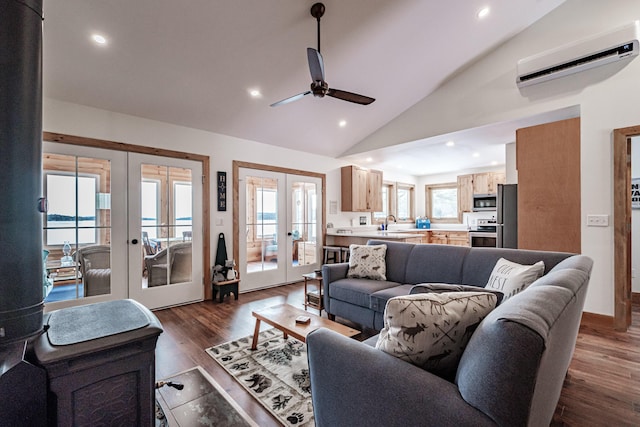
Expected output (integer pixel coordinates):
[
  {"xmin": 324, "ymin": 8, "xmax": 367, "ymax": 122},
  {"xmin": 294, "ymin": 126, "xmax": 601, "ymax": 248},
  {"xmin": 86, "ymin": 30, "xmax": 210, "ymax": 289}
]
[{"xmin": 251, "ymin": 304, "xmax": 360, "ymax": 350}]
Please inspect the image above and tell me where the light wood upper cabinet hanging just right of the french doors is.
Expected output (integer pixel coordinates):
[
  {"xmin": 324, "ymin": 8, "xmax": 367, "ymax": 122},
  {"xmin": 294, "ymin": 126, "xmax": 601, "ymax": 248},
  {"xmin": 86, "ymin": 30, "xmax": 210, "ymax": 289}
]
[{"xmin": 341, "ymin": 166, "xmax": 382, "ymax": 212}]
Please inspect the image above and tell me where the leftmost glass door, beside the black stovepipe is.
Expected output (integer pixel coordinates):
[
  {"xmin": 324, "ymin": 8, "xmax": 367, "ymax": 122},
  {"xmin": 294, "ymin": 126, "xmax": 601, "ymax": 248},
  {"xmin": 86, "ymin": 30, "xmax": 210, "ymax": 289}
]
[{"xmin": 43, "ymin": 143, "xmax": 126, "ymax": 309}]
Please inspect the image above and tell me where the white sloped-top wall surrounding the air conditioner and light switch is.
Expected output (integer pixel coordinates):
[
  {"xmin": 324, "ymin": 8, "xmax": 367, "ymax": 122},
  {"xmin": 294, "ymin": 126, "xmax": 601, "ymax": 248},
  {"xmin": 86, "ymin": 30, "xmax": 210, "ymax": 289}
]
[{"xmin": 344, "ymin": 0, "xmax": 640, "ymax": 316}]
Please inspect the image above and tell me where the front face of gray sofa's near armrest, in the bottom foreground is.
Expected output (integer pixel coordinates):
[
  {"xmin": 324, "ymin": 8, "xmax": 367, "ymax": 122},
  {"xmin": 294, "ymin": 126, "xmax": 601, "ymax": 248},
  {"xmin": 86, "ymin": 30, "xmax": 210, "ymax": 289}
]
[{"xmin": 307, "ymin": 328, "xmax": 495, "ymax": 427}]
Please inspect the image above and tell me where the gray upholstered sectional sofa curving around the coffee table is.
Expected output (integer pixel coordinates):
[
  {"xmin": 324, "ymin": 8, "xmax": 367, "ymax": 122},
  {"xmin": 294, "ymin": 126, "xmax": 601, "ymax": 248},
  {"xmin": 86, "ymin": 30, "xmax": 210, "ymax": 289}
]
[{"xmin": 307, "ymin": 241, "xmax": 592, "ymax": 426}]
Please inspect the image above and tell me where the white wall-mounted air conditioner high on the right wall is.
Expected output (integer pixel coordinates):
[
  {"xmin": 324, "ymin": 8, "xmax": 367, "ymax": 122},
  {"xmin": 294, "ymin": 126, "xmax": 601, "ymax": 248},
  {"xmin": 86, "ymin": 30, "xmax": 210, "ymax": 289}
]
[{"xmin": 516, "ymin": 21, "xmax": 640, "ymax": 87}]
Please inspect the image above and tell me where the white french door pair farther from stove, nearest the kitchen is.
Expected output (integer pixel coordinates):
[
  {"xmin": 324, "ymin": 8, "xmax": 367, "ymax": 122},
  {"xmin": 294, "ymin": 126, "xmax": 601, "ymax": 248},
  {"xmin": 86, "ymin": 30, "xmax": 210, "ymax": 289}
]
[{"xmin": 238, "ymin": 168, "xmax": 323, "ymax": 291}]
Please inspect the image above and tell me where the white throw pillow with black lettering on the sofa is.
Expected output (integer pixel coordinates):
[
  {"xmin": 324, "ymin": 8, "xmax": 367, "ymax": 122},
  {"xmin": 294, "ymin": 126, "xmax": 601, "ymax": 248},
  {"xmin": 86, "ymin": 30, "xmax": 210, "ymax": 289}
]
[{"xmin": 486, "ymin": 258, "xmax": 544, "ymax": 302}]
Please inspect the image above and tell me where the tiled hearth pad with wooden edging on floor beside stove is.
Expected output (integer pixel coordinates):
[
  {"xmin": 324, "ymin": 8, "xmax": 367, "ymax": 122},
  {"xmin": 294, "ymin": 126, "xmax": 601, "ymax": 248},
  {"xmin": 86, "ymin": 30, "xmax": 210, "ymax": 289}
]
[{"xmin": 156, "ymin": 366, "xmax": 257, "ymax": 427}]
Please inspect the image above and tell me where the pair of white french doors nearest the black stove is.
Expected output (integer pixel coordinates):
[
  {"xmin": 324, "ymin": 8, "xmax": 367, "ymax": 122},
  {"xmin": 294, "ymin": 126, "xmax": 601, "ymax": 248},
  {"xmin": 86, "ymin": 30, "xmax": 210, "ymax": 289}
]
[{"xmin": 43, "ymin": 141, "xmax": 203, "ymax": 310}]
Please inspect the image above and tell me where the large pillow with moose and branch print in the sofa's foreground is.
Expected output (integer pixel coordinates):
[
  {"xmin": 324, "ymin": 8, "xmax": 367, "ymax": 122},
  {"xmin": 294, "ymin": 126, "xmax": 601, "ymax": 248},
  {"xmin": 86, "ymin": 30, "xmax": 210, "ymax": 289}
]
[{"xmin": 376, "ymin": 292, "xmax": 497, "ymax": 379}]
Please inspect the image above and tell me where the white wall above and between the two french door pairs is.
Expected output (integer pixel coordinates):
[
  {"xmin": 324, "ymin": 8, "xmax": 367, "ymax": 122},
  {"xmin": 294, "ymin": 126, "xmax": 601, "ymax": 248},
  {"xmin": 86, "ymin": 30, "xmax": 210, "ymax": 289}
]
[{"xmin": 43, "ymin": 98, "xmax": 354, "ymax": 265}]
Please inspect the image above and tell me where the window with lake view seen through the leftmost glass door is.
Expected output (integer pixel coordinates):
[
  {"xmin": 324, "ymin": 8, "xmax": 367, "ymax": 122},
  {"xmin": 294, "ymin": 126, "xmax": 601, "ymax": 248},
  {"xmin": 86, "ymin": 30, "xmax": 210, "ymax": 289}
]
[{"xmin": 45, "ymin": 172, "xmax": 98, "ymax": 246}]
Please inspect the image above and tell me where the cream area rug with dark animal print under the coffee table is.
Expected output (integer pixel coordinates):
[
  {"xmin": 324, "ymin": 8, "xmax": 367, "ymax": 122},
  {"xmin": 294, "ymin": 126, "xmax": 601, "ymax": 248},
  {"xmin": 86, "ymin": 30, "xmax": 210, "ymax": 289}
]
[{"xmin": 206, "ymin": 329, "xmax": 315, "ymax": 427}]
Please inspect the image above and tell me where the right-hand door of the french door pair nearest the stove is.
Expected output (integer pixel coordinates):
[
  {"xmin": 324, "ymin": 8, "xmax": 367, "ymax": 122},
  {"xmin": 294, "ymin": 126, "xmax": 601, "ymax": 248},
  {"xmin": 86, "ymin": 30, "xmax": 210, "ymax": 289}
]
[{"xmin": 129, "ymin": 153, "xmax": 203, "ymax": 308}]
